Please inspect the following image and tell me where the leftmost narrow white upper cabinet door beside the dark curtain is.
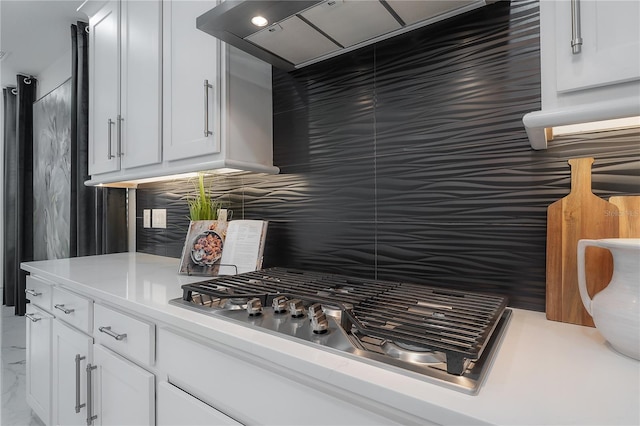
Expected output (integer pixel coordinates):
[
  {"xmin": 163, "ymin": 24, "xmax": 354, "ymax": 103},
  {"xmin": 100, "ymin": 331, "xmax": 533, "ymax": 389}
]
[{"xmin": 89, "ymin": 0, "xmax": 120, "ymax": 175}]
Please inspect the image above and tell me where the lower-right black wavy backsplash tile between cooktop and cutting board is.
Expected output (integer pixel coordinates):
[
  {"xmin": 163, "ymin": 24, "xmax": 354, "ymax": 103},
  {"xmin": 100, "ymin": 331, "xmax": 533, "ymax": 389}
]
[{"xmin": 377, "ymin": 222, "xmax": 546, "ymax": 309}]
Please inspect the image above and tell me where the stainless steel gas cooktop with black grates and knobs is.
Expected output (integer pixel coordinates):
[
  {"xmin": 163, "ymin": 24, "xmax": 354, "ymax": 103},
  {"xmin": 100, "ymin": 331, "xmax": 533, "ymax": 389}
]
[{"xmin": 170, "ymin": 268, "xmax": 511, "ymax": 394}]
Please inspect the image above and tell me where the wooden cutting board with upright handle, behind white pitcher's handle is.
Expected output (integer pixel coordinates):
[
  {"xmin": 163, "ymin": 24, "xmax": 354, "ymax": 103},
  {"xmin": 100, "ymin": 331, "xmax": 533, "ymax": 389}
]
[{"xmin": 546, "ymin": 157, "xmax": 619, "ymax": 327}]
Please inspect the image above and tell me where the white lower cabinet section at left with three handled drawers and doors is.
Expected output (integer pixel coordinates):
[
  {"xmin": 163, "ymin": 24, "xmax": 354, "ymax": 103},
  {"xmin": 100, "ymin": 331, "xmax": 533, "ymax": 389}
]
[{"xmin": 25, "ymin": 277, "xmax": 156, "ymax": 426}]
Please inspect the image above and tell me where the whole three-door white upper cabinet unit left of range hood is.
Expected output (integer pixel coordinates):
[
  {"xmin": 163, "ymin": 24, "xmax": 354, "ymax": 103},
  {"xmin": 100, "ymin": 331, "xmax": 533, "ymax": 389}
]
[{"xmin": 83, "ymin": 0, "xmax": 279, "ymax": 185}]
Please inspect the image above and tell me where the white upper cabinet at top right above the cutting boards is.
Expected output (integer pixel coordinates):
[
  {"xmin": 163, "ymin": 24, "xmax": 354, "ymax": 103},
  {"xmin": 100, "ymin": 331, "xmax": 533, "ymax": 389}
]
[{"xmin": 523, "ymin": 0, "xmax": 640, "ymax": 149}]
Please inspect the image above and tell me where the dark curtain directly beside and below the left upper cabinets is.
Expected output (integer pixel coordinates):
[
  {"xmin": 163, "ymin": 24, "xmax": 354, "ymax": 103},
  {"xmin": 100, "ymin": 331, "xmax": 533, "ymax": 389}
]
[{"xmin": 69, "ymin": 22, "xmax": 127, "ymax": 257}]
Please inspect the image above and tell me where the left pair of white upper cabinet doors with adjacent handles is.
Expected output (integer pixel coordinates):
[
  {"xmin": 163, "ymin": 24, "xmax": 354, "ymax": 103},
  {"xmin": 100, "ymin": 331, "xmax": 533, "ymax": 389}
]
[{"xmin": 89, "ymin": 0, "xmax": 162, "ymax": 176}]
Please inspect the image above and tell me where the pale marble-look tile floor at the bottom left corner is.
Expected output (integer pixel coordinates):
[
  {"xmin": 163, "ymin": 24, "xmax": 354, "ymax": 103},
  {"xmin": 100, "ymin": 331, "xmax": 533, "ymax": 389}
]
[{"xmin": 0, "ymin": 306, "xmax": 44, "ymax": 426}]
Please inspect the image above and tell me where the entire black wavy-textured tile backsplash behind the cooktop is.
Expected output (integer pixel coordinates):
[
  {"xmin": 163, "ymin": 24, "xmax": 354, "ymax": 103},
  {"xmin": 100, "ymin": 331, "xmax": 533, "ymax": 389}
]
[{"xmin": 137, "ymin": 1, "xmax": 640, "ymax": 310}]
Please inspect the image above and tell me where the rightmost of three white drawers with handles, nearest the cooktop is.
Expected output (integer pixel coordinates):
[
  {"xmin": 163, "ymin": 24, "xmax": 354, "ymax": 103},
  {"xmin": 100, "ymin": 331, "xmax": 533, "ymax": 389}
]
[{"xmin": 93, "ymin": 303, "xmax": 156, "ymax": 365}]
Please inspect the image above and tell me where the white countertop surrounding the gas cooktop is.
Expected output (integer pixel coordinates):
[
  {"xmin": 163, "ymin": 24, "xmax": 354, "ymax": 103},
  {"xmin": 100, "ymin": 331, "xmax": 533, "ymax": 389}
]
[{"xmin": 22, "ymin": 253, "xmax": 640, "ymax": 425}]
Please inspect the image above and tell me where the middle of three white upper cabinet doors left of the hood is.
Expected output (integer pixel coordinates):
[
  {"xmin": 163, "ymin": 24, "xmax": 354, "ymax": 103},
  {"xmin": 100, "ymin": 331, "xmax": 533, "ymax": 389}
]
[{"xmin": 120, "ymin": 0, "xmax": 162, "ymax": 168}]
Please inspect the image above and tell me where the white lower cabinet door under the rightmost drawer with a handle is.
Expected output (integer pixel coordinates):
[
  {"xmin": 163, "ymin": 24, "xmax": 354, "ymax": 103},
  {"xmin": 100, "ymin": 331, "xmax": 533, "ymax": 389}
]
[{"xmin": 92, "ymin": 345, "xmax": 155, "ymax": 426}]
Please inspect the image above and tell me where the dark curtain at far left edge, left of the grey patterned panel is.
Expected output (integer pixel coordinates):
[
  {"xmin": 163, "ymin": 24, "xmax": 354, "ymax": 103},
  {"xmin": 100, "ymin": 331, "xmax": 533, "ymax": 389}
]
[{"xmin": 4, "ymin": 74, "xmax": 37, "ymax": 315}]
